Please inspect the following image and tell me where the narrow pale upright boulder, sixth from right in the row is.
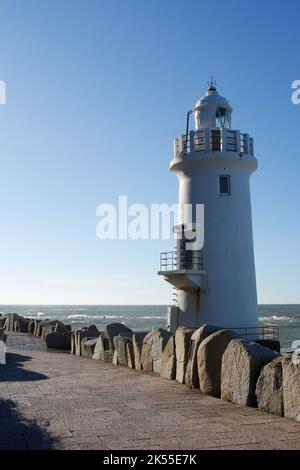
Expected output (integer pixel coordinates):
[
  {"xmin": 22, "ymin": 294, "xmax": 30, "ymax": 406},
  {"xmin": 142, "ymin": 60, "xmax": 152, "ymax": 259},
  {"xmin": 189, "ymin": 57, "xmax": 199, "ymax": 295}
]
[{"xmin": 175, "ymin": 326, "xmax": 195, "ymax": 384}]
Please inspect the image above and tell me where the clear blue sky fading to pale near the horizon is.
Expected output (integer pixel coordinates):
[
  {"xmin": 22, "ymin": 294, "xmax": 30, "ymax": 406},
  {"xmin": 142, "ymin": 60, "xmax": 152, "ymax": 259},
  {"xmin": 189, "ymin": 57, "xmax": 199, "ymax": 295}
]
[{"xmin": 0, "ymin": 0, "xmax": 300, "ymax": 304}]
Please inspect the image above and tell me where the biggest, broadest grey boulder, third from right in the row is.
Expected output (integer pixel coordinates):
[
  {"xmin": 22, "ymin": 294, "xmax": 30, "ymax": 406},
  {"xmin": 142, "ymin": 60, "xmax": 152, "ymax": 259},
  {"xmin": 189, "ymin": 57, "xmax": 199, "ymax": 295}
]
[{"xmin": 221, "ymin": 339, "xmax": 278, "ymax": 406}]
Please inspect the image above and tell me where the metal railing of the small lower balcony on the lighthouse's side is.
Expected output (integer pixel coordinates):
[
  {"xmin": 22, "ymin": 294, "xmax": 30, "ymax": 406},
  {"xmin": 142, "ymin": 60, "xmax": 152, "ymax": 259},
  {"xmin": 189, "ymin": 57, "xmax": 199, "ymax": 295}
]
[{"xmin": 160, "ymin": 250, "xmax": 203, "ymax": 271}]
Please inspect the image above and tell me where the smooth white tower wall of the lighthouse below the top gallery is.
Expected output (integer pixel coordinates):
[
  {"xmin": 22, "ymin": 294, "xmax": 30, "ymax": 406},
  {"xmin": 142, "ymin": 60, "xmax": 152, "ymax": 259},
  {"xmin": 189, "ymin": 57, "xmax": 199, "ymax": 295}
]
[{"xmin": 171, "ymin": 152, "xmax": 258, "ymax": 327}]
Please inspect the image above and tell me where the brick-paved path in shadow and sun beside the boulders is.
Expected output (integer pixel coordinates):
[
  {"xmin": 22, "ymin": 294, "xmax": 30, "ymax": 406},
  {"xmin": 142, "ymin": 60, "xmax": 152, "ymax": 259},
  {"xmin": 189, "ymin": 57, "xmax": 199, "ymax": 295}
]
[{"xmin": 0, "ymin": 333, "xmax": 300, "ymax": 450}]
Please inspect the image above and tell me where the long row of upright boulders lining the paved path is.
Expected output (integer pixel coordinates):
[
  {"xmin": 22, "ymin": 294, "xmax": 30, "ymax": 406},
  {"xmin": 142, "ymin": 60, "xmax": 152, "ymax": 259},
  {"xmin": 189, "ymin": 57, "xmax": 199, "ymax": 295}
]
[{"xmin": 0, "ymin": 314, "xmax": 300, "ymax": 421}]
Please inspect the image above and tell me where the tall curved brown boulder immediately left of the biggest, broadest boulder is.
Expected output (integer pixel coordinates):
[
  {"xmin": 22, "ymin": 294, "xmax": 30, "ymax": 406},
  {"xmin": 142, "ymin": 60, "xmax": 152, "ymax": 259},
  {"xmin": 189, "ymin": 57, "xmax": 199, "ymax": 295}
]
[{"xmin": 197, "ymin": 330, "xmax": 237, "ymax": 398}]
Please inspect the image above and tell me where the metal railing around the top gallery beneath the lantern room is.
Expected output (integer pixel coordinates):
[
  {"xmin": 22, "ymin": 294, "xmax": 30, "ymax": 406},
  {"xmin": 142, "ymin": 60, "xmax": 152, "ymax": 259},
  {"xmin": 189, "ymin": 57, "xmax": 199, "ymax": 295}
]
[{"xmin": 175, "ymin": 129, "xmax": 254, "ymax": 158}]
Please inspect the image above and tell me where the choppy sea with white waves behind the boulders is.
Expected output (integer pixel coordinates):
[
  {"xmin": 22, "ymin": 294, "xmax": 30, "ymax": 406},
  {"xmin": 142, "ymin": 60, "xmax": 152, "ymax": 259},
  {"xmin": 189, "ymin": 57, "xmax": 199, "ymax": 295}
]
[{"xmin": 0, "ymin": 305, "xmax": 300, "ymax": 350}]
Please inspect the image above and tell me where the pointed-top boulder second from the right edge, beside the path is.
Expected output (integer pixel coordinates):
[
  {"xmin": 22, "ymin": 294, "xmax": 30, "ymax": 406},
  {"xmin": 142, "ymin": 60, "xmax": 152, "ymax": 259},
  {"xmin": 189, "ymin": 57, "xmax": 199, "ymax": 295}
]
[{"xmin": 255, "ymin": 356, "xmax": 283, "ymax": 416}]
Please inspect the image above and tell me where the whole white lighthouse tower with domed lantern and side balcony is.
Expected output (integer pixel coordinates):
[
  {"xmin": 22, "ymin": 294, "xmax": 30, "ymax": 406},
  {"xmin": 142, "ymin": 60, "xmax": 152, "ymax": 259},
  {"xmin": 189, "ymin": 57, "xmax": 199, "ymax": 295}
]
[{"xmin": 158, "ymin": 80, "xmax": 258, "ymax": 332}]
